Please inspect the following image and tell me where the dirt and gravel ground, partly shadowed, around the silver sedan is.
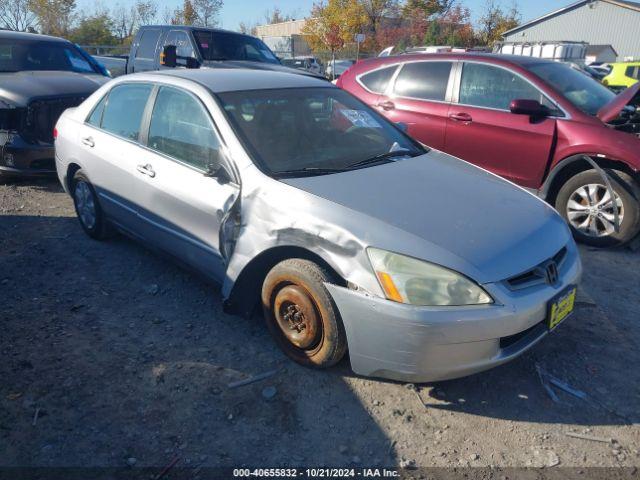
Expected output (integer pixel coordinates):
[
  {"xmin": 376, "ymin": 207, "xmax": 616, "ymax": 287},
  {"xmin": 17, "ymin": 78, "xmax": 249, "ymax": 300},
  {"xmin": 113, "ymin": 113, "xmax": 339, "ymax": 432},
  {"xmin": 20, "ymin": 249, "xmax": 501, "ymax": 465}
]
[{"xmin": 0, "ymin": 176, "xmax": 640, "ymax": 471}]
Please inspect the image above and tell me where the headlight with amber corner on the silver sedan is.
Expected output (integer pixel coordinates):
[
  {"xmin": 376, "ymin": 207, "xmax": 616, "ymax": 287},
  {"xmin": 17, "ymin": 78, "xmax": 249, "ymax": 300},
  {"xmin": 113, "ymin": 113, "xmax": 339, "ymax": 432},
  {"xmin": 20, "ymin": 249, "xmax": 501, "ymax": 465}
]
[{"xmin": 367, "ymin": 248, "xmax": 493, "ymax": 306}]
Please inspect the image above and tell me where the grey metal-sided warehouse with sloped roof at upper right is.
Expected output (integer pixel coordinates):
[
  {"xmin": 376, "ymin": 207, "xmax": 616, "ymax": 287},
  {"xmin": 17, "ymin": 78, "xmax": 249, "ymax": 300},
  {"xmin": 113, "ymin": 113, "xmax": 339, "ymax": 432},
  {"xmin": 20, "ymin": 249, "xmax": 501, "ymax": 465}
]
[{"xmin": 504, "ymin": 0, "xmax": 640, "ymax": 61}]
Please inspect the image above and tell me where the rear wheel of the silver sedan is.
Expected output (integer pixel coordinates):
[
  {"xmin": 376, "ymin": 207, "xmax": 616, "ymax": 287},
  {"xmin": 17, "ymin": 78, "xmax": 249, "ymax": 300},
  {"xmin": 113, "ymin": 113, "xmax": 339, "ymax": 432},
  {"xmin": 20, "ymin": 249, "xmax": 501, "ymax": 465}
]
[{"xmin": 72, "ymin": 170, "xmax": 111, "ymax": 240}]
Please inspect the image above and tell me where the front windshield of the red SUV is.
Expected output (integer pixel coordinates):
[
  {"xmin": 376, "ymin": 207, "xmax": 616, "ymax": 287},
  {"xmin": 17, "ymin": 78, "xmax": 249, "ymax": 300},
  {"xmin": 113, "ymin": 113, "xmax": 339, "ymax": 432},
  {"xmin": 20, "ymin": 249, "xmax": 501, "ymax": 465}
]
[{"xmin": 528, "ymin": 62, "xmax": 616, "ymax": 115}]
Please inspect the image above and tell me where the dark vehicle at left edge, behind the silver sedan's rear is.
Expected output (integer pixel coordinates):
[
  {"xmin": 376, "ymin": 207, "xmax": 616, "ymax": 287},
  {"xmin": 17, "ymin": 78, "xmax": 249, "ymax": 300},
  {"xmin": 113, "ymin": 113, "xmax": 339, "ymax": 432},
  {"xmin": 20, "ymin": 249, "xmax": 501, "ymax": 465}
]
[{"xmin": 0, "ymin": 31, "xmax": 109, "ymax": 176}]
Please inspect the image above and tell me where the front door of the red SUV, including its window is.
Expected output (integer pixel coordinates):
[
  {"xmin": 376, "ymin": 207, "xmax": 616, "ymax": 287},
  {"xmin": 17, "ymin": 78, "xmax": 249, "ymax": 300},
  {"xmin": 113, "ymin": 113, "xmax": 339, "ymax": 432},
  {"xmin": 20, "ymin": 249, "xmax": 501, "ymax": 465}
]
[{"xmin": 444, "ymin": 62, "xmax": 556, "ymax": 188}]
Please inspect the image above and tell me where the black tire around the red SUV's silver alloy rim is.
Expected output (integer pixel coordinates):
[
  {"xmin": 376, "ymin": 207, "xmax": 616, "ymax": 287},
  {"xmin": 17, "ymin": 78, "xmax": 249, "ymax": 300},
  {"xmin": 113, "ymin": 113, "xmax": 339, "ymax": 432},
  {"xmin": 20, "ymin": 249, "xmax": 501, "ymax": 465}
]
[{"xmin": 555, "ymin": 170, "xmax": 640, "ymax": 247}]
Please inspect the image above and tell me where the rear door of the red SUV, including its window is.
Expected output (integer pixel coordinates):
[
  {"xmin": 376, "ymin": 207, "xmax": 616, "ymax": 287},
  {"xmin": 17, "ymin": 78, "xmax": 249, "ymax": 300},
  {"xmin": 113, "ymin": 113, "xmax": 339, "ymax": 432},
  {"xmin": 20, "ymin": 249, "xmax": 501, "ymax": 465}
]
[{"xmin": 374, "ymin": 61, "xmax": 453, "ymax": 150}]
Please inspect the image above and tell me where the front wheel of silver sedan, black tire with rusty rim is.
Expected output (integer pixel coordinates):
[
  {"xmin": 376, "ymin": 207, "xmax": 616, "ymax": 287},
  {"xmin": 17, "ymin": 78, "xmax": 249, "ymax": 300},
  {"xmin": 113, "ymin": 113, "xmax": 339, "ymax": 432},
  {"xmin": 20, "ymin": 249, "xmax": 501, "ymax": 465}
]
[{"xmin": 262, "ymin": 259, "xmax": 347, "ymax": 368}]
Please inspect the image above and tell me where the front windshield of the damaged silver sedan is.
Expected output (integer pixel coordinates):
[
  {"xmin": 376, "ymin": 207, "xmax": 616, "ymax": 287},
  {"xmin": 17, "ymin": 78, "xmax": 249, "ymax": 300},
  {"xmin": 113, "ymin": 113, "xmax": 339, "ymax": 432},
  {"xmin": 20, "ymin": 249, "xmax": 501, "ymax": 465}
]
[{"xmin": 218, "ymin": 88, "xmax": 425, "ymax": 176}]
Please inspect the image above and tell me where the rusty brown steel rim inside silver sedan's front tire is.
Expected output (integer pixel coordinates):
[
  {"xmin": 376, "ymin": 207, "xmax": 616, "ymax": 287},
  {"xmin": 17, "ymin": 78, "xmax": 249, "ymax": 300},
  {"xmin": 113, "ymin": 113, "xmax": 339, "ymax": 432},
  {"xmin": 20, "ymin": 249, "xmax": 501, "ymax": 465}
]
[{"xmin": 273, "ymin": 285, "xmax": 322, "ymax": 350}]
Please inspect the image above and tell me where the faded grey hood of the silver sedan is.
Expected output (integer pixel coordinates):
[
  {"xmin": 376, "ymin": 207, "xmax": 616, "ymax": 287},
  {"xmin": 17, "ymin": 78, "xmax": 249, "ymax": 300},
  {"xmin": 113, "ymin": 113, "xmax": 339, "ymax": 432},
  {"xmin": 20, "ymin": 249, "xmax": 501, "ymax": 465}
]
[{"xmin": 283, "ymin": 151, "xmax": 571, "ymax": 283}]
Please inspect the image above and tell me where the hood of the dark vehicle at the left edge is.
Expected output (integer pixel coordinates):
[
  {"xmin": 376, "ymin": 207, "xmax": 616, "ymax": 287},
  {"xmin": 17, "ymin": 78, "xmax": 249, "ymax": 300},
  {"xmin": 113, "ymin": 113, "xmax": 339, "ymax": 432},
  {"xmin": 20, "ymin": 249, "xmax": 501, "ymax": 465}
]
[{"xmin": 0, "ymin": 71, "xmax": 110, "ymax": 106}]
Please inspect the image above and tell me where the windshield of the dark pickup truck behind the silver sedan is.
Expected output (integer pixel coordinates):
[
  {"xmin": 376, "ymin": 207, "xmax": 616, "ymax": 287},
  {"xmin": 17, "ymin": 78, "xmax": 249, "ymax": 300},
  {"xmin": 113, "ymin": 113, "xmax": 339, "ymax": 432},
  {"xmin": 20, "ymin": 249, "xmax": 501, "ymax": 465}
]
[{"xmin": 194, "ymin": 30, "xmax": 280, "ymax": 64}]
